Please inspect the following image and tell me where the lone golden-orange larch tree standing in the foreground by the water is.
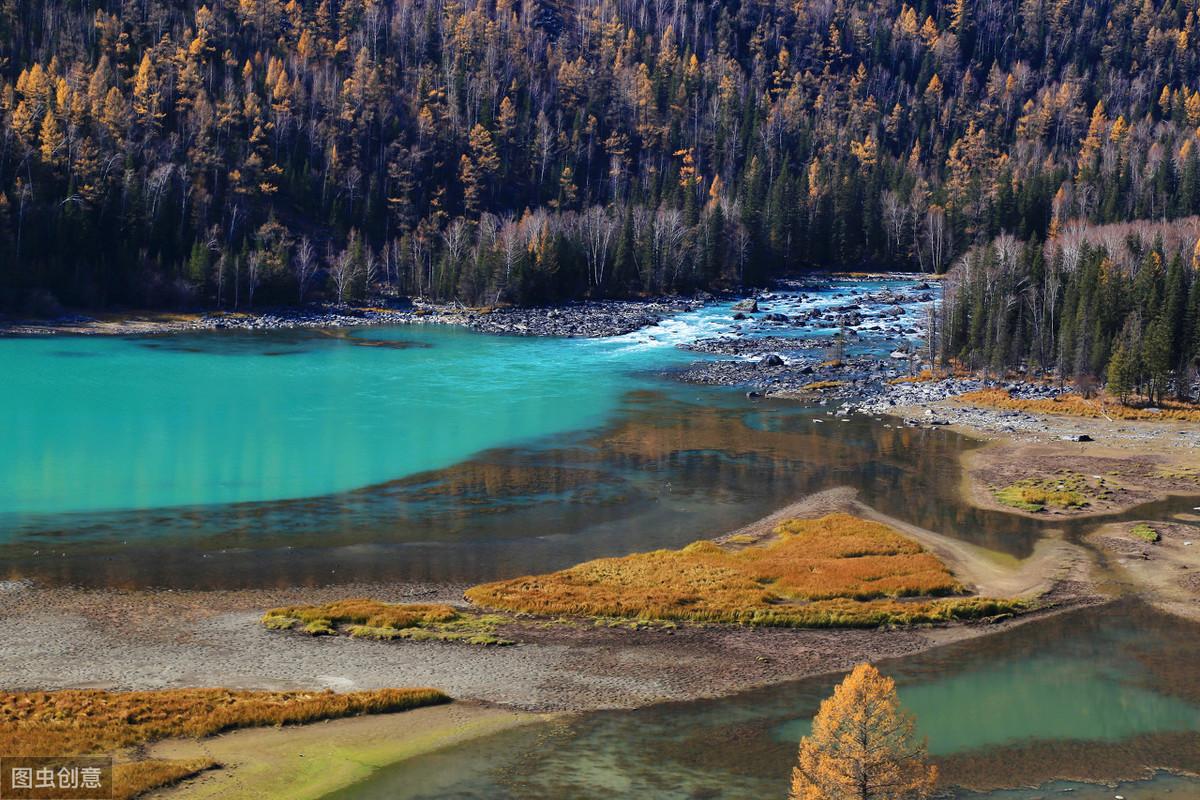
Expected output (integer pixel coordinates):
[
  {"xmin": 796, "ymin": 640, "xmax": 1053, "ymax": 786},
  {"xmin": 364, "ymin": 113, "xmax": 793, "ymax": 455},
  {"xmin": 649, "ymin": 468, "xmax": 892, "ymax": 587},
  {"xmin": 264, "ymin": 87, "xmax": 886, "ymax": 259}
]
[{"xmin": 788, "ymin": 663, "xmax": 937, "ymax": 800}]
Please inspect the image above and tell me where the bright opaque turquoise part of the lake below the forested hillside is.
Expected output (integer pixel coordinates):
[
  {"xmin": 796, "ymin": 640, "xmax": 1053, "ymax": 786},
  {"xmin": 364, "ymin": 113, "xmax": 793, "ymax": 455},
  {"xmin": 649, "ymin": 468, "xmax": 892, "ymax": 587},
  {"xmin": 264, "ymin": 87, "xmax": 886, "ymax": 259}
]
[{"xmin": 0, "ymin": 326, "xmax": 673, "ymax": 515}]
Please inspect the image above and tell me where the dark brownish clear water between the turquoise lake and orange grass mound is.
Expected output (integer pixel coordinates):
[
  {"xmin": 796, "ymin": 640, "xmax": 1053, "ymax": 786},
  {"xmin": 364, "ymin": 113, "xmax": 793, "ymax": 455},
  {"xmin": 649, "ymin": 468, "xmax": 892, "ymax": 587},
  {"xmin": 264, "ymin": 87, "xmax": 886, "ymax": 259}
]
[{"xmin": 5, "ymin": 381, "xmax": 1194, "ymax": 588}]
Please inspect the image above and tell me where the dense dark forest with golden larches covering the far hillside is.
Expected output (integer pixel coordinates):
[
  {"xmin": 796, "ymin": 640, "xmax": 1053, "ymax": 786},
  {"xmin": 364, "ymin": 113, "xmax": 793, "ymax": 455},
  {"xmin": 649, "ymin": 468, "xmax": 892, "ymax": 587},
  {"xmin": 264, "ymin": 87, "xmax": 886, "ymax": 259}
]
[{"xmin": 0, "ymin": 0, "xmax": 1200, "ymax": 328}]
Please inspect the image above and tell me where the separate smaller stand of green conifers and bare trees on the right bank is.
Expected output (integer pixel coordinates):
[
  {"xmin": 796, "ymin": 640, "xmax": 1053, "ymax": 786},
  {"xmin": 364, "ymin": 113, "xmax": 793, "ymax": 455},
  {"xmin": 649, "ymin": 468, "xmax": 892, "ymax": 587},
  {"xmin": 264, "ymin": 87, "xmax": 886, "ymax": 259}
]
[{"xmin": 938, "ymin": 217, "xmax": 1200, "ymax": 403}]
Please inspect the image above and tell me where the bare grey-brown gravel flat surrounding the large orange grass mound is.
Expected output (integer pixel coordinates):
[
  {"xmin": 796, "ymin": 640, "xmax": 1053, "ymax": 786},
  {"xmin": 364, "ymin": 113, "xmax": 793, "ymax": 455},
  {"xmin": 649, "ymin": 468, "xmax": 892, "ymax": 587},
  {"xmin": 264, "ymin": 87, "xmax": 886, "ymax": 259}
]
[{"xmin": 0, "ymin": 489, "xmax": 1103, "ymax": 712}]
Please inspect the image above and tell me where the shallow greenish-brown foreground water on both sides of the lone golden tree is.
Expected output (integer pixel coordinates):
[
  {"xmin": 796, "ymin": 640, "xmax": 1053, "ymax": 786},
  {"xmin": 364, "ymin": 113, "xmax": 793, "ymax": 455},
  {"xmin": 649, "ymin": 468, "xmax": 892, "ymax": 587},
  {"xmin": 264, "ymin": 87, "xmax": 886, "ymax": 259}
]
[{"xmin": 332, "ymin": 603, "xmax": 1200, "ymax": 800}]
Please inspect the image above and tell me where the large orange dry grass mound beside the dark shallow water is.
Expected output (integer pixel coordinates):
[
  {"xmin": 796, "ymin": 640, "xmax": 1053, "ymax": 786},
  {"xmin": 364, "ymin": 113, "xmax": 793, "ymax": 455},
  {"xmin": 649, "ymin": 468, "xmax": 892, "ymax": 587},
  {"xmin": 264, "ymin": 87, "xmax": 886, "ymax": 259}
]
[{"xmin": 467, "ymin": 513, "xmax": 1020, "ymax": 626}]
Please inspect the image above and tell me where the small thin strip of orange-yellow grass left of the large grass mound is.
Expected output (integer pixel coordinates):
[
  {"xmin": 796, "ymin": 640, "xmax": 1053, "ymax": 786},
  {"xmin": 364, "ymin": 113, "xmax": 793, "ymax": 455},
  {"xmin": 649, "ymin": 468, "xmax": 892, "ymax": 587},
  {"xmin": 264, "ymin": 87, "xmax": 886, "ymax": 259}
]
[{"xmin": 262, "ymin": 597, "xmax": 512, "ymax": 645}]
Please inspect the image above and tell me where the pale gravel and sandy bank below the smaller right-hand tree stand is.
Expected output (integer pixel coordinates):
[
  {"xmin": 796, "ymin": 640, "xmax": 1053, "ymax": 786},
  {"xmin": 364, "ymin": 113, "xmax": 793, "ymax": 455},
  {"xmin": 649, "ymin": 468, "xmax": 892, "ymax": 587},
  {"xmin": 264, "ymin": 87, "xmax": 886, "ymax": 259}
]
[{"xmin": 859, "ymin": 397, "xmax": 1200, "ymax": 620}]
